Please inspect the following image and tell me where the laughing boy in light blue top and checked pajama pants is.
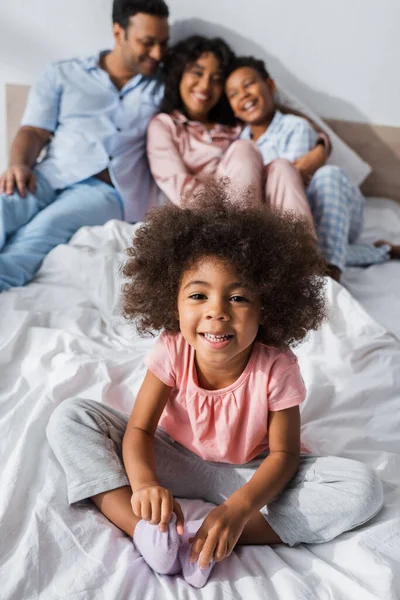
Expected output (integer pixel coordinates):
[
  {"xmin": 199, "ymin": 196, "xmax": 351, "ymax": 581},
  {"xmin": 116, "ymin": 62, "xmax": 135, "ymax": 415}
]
[{"xmin": 226, "ymin": 56, "xmax": 400, "ymax": 281}]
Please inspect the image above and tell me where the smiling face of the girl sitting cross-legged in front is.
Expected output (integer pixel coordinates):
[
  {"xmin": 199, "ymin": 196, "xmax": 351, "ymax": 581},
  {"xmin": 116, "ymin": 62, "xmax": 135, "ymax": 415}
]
[{"xmin": 178, "ymin": 256, "xmax": 260, "ymax": 369}]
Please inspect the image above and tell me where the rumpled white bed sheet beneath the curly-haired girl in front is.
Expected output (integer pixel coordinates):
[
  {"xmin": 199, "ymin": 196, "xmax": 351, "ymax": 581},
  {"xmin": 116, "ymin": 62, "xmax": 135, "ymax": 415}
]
[{"xmin": 0, "ymin": 201, "xmax": 400, "ymax": 600}]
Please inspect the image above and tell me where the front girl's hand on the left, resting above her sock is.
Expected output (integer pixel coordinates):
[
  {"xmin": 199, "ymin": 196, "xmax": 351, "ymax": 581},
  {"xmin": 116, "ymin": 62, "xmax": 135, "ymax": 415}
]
[{"xmin": 131, "ymin": 484, "xmax": 184, "ymax": 535}]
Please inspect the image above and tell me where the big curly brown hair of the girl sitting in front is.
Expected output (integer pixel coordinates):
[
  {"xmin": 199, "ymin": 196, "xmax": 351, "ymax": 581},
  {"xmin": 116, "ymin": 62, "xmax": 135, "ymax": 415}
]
[{"xmin": 122, "ymin": 182, "xmax": 325, "ymax": 347}]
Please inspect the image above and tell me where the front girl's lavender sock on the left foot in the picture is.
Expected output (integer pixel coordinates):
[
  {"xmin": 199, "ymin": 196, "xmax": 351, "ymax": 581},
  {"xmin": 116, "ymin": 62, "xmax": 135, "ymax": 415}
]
[{"xmin": 133, "ymin": 515, "xmax": 181, "ymax": 575}]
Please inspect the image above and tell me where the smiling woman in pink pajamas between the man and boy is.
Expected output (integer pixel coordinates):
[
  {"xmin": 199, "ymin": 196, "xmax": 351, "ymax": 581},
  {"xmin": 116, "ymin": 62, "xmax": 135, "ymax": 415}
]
[{"xmin": 147, "ymin": 36, "xmax": 325, "ymax": 219}]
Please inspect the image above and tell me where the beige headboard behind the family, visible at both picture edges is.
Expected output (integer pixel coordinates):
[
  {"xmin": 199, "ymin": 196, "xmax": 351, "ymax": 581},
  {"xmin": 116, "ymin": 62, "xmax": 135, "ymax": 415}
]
[{"xmin": 6, "ymin": 85, "xmax": 400, "ymax": 202}]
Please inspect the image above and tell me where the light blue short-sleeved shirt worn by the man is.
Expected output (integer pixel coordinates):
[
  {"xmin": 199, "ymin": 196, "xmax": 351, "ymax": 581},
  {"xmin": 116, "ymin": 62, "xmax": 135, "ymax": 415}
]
[{"xmin": 21, "ymin": 55, "xmax": 164, "ymax": 222}]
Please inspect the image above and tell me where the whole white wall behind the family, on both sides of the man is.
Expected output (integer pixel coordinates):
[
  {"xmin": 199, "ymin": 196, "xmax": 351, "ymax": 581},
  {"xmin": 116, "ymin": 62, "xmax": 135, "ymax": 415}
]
[{"xmin": 0, "ymin": 0, "xmax": 400, "ymax": 167}]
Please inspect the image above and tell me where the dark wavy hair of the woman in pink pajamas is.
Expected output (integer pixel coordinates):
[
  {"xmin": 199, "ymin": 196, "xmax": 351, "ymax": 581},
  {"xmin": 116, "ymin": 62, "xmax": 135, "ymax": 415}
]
[{"xmin": 160, "ymin": 35, "xmax": 237, "ymax": 126}]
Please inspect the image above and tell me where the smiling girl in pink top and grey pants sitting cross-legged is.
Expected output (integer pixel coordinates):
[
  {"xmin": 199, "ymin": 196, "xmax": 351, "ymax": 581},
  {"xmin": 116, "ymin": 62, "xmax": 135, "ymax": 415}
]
[{"xmin": 47, "ymin": 182, "xmax": 382, "ymax": 587}]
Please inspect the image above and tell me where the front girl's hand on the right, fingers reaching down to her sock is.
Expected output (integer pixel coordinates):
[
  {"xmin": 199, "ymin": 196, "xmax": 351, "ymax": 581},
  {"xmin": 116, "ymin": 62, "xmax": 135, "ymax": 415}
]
[{"xmin": 189, "ymin": 503, "xmax": 251, "ymax": 569}]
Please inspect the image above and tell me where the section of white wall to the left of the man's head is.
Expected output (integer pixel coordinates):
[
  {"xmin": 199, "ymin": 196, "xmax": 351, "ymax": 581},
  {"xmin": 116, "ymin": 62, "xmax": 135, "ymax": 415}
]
[{"xmin": 0, "ymin": 0, "xmax": 112, "ymax": 171}]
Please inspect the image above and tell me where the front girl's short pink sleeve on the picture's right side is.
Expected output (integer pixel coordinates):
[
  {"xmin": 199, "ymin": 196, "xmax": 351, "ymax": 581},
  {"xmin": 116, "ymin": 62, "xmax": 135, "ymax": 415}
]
[{"xmin": 268, "ymin": 350, "xmax": 306, "ymax": 411}]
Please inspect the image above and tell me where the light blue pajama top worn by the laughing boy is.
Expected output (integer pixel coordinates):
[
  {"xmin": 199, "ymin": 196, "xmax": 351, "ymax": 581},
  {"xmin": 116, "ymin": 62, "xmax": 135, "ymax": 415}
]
[{"xmin": 240, "ymin": 110, "xmax": 319, "ymax": 165}]
